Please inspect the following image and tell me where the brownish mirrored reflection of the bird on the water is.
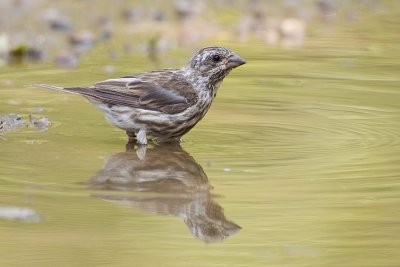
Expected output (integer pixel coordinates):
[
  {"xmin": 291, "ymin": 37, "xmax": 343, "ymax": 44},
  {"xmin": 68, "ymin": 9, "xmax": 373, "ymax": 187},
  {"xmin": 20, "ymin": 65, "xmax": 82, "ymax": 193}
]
[{"xmin": 88, "ymin": 143, "xmax": 241, "ymax": 242}]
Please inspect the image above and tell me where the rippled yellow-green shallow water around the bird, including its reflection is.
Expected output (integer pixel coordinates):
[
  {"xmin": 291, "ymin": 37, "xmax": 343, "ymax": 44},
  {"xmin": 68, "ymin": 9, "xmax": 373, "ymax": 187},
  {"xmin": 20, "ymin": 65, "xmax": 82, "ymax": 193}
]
[{"xmin": 0, "ymin": 22, "xmax": 400, "ymax": 267}]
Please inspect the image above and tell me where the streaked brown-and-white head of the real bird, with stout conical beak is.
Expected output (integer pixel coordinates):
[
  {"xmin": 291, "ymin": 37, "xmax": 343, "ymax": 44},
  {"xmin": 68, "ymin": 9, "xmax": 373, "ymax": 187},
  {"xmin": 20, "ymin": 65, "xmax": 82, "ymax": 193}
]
[{"xmin": 189, "ymin": 46, "xmax": 246, "ymax": 82}]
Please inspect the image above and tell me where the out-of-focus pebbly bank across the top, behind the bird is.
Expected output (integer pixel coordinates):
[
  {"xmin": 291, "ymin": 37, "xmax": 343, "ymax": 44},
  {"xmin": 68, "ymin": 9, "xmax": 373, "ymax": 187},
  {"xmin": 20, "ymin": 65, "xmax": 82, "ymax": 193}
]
[{"xmin": 0, "ymin": 0, "xmax": 399, "ymax": 69}]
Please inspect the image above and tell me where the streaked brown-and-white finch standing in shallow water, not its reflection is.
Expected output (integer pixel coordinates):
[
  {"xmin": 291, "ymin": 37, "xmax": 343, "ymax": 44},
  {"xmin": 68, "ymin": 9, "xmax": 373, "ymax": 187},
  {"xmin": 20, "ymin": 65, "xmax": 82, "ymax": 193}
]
[{"xmin": 34, "ymin": 46, "xmax": 246, "ymax": 145}]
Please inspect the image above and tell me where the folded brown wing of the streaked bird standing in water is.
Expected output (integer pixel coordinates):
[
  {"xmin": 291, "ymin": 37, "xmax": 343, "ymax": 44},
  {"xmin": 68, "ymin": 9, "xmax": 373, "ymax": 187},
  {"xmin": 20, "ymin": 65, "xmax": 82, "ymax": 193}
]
[{"xmin": 59, "ymin": 70, "xmax": 196, "ymax": 114}]
